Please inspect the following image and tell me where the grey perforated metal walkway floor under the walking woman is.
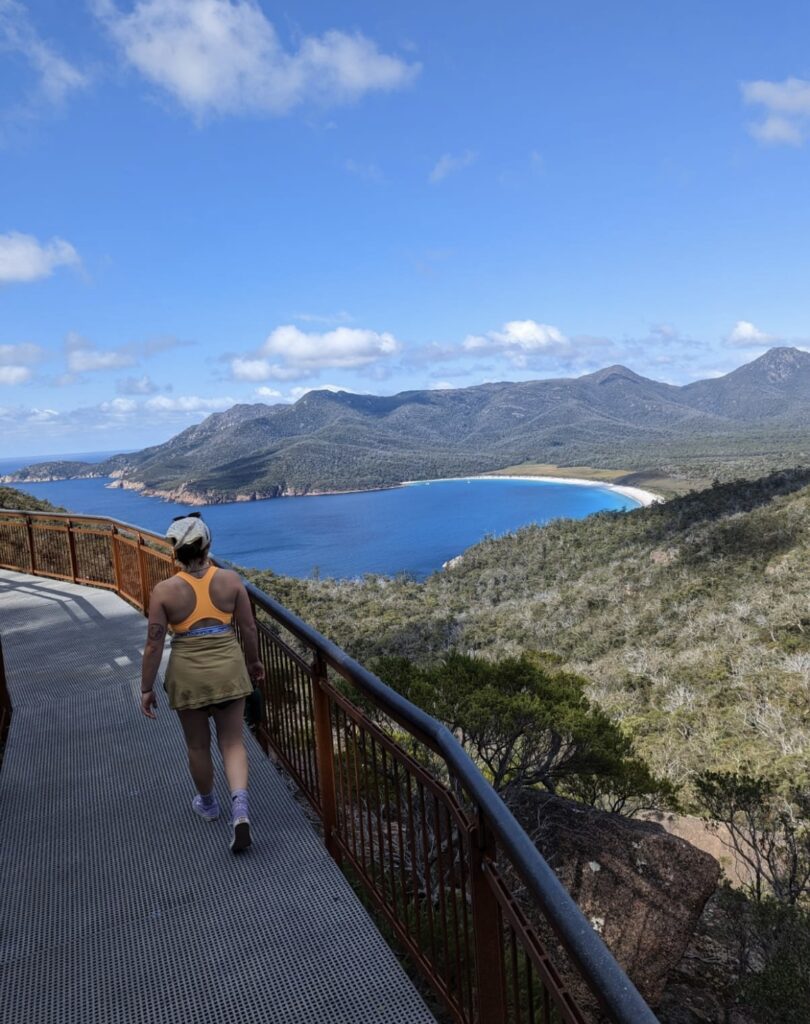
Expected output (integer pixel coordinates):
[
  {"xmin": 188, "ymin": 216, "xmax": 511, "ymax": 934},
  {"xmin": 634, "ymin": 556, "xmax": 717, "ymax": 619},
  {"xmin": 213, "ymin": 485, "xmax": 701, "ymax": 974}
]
[{"xmin": 0, "ymin": 572, "xmax": 433, "ymax": 1024}]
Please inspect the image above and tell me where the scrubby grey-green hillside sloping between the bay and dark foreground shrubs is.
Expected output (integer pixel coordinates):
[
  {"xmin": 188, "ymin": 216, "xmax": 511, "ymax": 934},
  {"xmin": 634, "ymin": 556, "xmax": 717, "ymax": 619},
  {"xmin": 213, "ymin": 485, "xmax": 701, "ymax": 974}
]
[{"xmin": 252, "ymin": 469, "xmax": 810, "ymax": 804}]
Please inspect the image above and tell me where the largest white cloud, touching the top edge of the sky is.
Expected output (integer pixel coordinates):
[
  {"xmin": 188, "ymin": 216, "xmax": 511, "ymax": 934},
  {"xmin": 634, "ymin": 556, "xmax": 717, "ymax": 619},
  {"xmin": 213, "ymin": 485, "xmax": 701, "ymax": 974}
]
[{"xmin": 94, "ymin": 0, "xmax": 420, "ymax": 116}]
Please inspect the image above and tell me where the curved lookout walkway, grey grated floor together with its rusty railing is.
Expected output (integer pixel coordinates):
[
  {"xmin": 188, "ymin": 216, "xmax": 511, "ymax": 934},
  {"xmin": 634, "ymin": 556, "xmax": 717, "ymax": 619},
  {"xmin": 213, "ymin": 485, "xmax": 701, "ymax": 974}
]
[{"xmin": 0, "ymin": 509, "xmax": 655, "ymax": 1024}]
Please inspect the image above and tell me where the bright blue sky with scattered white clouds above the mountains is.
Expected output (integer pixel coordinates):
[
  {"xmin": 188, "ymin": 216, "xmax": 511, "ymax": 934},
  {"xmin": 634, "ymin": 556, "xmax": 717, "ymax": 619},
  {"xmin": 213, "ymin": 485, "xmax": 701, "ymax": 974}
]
[{"xmin": 0, "ymin": 0, "xmax": 810, "ymax": 457}]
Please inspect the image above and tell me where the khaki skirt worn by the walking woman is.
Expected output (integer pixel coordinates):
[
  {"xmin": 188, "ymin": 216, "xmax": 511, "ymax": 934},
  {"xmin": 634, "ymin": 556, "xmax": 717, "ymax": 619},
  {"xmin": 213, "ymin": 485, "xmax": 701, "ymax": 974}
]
[{"xmin": 163, "ymin": 633, "xmax": 253, "ymax": 711}]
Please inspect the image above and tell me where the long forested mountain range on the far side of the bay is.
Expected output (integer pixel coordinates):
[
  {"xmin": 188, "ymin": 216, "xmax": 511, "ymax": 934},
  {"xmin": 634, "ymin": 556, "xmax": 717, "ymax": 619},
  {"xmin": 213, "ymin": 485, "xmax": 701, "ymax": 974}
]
[{"xmin": 3, "ymin": 348, "xmax": 810, "ymax": 504}]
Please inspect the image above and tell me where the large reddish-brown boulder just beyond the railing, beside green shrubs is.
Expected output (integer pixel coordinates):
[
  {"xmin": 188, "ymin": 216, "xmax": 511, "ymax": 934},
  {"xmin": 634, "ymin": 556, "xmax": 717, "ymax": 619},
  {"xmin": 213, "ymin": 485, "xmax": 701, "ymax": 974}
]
[{"xmin": 516, "ymin": 792, "xmax": 720, "ymax": 1007}]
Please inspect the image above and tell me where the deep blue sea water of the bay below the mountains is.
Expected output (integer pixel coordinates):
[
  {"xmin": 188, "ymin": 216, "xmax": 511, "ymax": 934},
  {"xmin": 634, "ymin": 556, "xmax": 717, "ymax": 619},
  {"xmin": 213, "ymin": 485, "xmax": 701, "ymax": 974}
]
[{"xmin": 0, "ymin": 453, "xmax": 637, "ymax": 579}]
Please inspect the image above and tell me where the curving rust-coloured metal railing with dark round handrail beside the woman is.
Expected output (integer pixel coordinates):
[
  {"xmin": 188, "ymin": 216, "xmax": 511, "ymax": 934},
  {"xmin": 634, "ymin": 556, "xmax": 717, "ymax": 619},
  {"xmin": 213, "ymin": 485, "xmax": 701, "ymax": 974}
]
[{"xmin": 0, "ymin": 511, "xmax": 655, "ymax": 1024}]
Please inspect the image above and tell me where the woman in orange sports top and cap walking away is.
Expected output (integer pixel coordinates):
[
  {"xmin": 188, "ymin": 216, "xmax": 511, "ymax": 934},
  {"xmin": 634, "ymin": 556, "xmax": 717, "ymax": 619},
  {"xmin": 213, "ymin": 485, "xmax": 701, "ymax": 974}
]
[{"xmin": 140, "ymin": 512, "xmax": 264, "ymax": 853}]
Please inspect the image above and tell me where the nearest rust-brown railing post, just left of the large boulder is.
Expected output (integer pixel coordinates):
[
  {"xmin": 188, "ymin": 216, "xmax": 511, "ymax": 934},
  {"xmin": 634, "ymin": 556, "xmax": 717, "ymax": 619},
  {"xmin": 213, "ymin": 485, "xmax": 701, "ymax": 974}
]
[{"xmin": 470, "ymin": 811, "xmax": 508, "ymax": 1024}]
